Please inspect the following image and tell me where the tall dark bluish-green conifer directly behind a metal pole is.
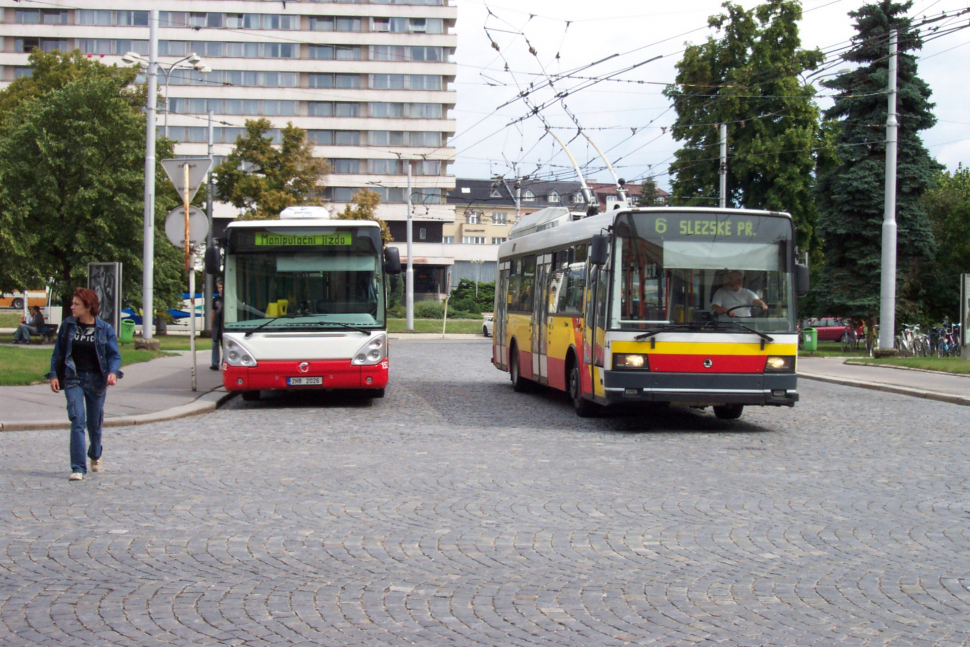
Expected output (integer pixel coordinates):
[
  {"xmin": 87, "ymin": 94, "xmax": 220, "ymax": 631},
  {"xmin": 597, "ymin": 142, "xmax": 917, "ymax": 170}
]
[{"xmin": 813, "ymin": 0, "xmax": 940, "ymax": 320}]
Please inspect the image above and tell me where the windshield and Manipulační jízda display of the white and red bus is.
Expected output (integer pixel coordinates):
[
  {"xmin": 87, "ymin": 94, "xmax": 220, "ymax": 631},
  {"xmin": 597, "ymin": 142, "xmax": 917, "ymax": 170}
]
[{"xmin": 224, "ymin": 229, "xmax": 385, "ymax": 330}]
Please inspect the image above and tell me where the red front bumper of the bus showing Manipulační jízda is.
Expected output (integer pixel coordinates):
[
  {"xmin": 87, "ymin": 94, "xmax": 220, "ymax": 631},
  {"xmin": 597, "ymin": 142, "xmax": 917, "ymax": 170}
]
[{"xmin": 222, "ymin": 358, "xmax": 388, "ymax": 391}]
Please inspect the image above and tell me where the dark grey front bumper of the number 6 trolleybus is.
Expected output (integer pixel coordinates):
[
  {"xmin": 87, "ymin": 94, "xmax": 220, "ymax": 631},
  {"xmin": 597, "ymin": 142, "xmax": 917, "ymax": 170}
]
[{"xmin": 603, "ymin": 371, "xmax": 798, "ymax": 407}]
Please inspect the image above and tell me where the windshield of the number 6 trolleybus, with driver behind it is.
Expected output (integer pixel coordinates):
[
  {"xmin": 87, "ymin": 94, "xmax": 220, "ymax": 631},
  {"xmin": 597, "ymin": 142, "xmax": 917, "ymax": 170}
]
[{"xmin": 610, "ymin": 211, "xmax": 794, "ymax": 332}]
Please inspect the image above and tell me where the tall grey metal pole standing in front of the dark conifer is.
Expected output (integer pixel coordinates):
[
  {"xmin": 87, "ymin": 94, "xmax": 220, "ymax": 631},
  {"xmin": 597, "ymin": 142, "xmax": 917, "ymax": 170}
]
[{"xmin": 879, "ymin": 29, "xmax": 899, "ymax": 350}]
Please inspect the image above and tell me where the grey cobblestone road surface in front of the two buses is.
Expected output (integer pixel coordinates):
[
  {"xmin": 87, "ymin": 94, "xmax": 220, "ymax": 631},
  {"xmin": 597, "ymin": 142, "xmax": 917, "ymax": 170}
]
[{"xmin": 0, "ymin": 340, "xmax": 970, "ymax": 647}]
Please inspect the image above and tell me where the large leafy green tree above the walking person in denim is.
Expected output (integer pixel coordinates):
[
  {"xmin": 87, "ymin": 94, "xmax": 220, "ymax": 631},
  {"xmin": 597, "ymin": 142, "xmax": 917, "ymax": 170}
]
[{"xmin": 0, "ymin": 52, "xmax": 181, "ymax": 312}]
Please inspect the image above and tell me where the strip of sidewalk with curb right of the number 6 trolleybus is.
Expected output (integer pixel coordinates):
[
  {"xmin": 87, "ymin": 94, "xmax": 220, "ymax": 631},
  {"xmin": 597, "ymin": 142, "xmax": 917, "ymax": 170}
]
[{"xmin": 798, "ymin": 356, "xmax": 970, "ymax": 406}]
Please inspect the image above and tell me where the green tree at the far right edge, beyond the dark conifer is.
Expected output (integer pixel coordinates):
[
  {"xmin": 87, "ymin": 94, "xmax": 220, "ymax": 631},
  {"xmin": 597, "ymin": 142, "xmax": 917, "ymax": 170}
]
[{"xmin": 923, "ymin": 167, "xmax": 970, "ymax": 322}]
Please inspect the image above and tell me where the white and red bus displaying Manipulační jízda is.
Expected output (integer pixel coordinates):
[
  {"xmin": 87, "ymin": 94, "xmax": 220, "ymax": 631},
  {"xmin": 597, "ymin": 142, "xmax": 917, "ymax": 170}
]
[{"xmin": 216, "ymin": 207, "xmax": 401, "ymax": 400}]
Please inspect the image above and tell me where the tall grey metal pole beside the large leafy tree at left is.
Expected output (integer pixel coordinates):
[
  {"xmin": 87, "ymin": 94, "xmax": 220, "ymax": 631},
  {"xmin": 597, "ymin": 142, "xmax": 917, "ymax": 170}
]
[{"xmin": 141, "ymin": 9, "xmax": 158, "ymax": 339}]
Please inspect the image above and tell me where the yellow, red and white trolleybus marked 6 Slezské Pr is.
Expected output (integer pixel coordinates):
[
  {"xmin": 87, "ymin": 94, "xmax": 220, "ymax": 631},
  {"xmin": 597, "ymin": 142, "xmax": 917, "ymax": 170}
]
[{"xmin": 492, "ymin": 207, "xmax": 808, "ymax": 419}]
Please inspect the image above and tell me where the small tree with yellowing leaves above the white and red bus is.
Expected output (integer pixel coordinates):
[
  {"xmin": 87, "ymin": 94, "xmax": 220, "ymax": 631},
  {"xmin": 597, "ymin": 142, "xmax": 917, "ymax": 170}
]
[{"xmin": 214, "ymin": 119, "xmax": 330, "ymax": 219}]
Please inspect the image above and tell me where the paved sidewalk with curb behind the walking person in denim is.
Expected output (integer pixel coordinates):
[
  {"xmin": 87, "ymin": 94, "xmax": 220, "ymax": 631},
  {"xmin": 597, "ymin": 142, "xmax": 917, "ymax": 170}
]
[{"xmin": 0, "ymin": 348, "xmax": 230, "ymax": 431}]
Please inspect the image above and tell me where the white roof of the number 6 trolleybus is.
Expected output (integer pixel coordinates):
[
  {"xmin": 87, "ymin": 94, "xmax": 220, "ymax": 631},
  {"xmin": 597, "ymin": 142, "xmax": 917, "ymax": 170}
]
[{"xmin": 498, "ymin": 207, "xmax": 791, "ymax": 260}]
